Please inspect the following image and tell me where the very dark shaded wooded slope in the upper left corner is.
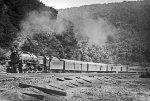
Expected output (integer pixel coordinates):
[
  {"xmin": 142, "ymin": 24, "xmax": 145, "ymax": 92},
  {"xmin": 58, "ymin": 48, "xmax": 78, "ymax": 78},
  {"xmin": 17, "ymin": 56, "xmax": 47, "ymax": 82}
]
[{"xmin": 0, "ymin": 0, "xmax": 58, "ymax": 53}]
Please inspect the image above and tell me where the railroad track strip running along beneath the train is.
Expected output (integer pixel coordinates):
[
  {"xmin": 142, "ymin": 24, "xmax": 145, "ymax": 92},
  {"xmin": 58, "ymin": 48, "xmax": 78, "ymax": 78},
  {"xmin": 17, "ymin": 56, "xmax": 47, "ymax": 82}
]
[{"xmin": 0, "ymin": 73, "xmax": 139, "ymax": 81}]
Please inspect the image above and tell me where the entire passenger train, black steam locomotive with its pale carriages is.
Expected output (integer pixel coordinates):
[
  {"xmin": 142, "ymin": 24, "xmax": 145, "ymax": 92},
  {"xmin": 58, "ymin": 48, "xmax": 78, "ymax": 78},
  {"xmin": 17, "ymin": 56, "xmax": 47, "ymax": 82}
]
[{"xmin": 7, "ymin": 48, "xmax": 132, "ymax": 73}]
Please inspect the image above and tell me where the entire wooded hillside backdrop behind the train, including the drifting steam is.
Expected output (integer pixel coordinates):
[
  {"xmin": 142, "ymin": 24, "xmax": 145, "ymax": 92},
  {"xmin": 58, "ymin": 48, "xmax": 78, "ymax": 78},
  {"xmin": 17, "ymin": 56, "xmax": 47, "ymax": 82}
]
[{"xmin": 0, "ymin": 0, "xmax": 150, "ymax": 65}]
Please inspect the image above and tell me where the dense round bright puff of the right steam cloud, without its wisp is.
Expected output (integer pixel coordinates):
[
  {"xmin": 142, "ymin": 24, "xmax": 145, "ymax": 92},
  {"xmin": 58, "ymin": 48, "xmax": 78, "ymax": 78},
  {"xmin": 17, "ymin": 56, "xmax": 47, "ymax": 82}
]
[{"xmin": 80, "ymin": 18, "xmax": 116, "ymax": 45}]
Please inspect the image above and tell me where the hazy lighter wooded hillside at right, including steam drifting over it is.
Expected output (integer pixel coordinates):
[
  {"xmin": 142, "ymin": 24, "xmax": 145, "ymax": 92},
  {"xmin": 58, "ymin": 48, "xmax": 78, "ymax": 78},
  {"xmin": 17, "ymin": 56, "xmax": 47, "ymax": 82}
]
[{"xmin": 58, "ymin": 0, "xmax": 150, "ymax": 64}]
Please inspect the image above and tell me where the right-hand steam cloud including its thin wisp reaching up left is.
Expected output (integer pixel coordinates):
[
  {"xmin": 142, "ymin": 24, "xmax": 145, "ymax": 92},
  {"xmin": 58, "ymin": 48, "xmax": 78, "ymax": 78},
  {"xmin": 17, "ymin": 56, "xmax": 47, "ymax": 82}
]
[{"xmin": 60, "ymin": 8, "xmax": 117, "ymax": 46}]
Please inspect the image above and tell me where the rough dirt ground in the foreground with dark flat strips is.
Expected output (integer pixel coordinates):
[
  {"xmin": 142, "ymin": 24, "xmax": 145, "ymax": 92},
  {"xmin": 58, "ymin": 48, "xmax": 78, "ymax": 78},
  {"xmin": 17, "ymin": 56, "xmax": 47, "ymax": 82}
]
[{"xmin": 0, "ymin": 74, "xmax": 150, "ymax": 101}]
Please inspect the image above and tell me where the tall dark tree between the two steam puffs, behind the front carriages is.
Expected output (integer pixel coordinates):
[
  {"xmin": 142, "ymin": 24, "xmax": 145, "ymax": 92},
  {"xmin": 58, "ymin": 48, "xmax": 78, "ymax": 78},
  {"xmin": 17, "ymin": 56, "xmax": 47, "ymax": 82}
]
[{"xmin": 56, "ymin": 20, "xmax": 77, "ymax": 59}]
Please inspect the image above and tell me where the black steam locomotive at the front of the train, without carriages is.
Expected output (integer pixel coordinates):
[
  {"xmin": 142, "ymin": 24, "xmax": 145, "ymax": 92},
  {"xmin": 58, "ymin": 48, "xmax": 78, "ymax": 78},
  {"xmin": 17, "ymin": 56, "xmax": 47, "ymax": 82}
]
[{"xmin": 7, "ymin": 51, "xmax": 39, "ymax": 73}]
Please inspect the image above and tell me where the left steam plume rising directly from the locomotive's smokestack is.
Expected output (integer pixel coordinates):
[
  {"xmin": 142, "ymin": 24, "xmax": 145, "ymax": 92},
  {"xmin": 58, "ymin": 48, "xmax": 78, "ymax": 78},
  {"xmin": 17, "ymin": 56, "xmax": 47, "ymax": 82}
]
[{"xmin": 15, "ymin": 11, "xmax": 55, "ymax": 46}]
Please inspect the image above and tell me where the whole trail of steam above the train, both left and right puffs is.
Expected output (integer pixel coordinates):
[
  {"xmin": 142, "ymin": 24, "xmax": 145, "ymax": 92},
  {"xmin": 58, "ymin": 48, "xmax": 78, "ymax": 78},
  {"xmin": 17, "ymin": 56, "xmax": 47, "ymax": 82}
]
[{"xmin": 18, "ymin": 7, "xmax": 116, "ymax": 46}]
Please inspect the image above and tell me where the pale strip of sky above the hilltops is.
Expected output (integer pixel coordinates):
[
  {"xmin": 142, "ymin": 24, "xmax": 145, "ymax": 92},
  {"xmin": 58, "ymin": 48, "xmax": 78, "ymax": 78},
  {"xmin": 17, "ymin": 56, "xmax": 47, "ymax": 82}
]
[{"xmin": 40, "ymin": 0, "xmax": 136, "ymax": 9}]
